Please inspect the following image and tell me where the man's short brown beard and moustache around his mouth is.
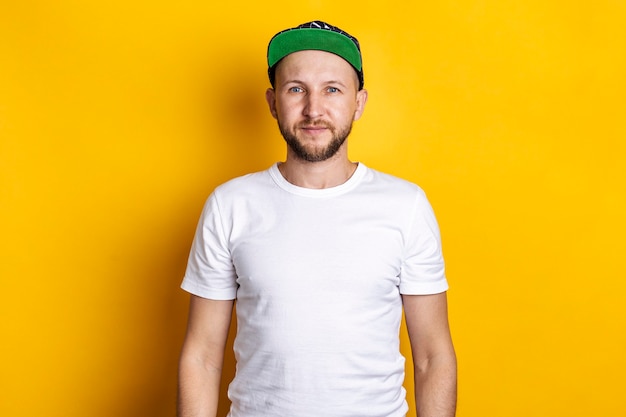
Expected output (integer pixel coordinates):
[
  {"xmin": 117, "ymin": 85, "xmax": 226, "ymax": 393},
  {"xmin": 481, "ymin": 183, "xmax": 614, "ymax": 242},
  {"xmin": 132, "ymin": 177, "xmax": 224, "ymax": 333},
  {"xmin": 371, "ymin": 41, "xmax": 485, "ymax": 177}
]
[{"xmin": 278, "ymin": 120, "xmax": 352, "ymax": 162}]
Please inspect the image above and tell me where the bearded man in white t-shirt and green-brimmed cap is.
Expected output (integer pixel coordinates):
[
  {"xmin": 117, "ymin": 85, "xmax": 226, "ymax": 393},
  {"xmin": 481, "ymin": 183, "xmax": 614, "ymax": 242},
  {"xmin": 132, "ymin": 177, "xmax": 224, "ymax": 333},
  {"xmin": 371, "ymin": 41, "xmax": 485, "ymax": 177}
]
[{"xmin": 179, "ymin": 21, "xmax": 456, "ymax": 417}]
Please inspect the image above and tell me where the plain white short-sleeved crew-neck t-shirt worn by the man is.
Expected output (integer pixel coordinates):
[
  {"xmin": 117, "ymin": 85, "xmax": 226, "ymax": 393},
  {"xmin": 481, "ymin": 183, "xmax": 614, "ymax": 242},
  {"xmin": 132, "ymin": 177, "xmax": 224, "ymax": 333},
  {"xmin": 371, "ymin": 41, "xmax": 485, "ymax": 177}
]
[{"xmin": 182, "ymin": 164, "xmax": 448, "ymax": 417}]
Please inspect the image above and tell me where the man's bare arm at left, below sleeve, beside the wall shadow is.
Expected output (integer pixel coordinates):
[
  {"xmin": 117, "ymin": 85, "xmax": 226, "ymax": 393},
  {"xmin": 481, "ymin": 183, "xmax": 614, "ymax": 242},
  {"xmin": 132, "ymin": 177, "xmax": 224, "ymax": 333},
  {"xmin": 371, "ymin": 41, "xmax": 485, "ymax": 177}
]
[{"xmin": 178, "ymin": 295, "xmax": 233, "ymax": 417}]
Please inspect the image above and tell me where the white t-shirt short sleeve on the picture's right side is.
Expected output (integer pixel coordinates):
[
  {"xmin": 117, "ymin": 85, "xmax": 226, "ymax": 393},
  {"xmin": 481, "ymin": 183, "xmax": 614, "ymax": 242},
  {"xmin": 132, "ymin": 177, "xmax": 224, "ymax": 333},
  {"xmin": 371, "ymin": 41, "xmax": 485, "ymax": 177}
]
[{"xmin": 400, "ymin": 190, "xmax": 448, "ymax": 295}]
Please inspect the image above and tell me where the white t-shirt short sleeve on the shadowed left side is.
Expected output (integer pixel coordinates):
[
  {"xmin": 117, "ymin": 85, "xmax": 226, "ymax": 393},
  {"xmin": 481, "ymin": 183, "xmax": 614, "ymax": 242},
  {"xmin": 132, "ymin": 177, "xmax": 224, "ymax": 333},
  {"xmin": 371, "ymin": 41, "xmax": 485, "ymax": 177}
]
[{"xmin": 181, "ymin": 193, "xmax": 237, "ymax": 300}]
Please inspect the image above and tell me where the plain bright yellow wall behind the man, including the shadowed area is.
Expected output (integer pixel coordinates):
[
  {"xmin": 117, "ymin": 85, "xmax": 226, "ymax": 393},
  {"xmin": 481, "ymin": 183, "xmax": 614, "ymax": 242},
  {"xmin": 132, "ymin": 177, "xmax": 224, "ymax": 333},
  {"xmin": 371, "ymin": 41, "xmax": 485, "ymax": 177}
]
[{"xmin": 0, "ymin": 0, "xmax": 626, "ymax": 417}]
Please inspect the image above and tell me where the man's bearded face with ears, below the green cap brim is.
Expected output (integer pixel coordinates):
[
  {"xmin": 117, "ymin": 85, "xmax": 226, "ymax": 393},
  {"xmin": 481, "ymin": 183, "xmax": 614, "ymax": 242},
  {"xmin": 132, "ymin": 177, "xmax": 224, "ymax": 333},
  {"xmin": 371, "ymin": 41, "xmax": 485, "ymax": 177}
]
[{"xmin": 266, "ymin": 51, "xmax": 367, "ymax": 162}]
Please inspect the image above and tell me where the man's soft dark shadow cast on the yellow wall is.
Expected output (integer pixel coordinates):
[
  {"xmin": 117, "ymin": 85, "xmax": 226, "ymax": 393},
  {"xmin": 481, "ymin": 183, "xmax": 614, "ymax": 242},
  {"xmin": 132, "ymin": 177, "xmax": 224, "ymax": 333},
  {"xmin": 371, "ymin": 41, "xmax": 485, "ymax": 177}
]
[{"xmin": 106, "ymin": 45, "xmax": 274, "ymax": 417}]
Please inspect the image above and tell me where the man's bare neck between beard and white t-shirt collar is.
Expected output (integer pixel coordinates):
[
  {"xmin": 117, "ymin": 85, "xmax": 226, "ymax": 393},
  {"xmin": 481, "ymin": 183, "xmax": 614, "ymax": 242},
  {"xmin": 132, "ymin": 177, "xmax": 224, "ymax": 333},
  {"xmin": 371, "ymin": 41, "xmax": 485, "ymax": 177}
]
[{"xmin": 278, "ymin": 154, "xmax": 358, "ymax": 189}]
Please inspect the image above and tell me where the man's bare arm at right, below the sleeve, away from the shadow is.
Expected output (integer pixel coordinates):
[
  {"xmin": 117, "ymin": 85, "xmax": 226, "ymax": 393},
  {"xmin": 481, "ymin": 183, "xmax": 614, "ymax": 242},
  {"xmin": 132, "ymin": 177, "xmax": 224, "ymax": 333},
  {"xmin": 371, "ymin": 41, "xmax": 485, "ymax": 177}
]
[{"xmin": 402, "ymin": 292, "xmax": 456, "ymax": 417}]
